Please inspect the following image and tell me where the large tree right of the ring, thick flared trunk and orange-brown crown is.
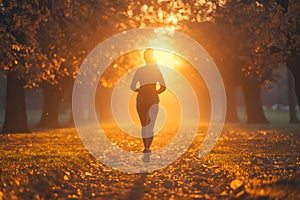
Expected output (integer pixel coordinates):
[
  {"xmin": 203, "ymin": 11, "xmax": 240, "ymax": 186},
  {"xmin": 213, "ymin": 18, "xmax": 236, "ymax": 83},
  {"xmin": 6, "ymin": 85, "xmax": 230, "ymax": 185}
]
[{"xmin": 191, "ymin": 1, "xmax": 297, "ymax": 123}]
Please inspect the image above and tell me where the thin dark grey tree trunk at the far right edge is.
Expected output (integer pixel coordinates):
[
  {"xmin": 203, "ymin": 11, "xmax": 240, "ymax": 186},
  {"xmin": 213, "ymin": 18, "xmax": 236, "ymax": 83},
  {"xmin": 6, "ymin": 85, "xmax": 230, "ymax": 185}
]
[{"xmin": 287, "ymin": 70, "xmax": 299, "ymax": 123}]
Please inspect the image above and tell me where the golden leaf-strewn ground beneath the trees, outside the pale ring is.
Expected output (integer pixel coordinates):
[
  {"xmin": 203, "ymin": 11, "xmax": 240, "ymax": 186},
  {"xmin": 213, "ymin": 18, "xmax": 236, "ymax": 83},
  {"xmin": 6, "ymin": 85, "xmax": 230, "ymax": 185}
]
[{"xmin": 0, "ymin": 125, "xmax": 300, "ymax": 199}]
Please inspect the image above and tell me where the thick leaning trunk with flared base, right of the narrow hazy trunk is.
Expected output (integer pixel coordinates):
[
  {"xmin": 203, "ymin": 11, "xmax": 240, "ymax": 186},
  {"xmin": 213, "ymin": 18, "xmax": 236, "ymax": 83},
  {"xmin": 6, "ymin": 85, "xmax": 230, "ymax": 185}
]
[{"xmin": 242, "ymin": 79, "xmax": 269, "ymax": 124}]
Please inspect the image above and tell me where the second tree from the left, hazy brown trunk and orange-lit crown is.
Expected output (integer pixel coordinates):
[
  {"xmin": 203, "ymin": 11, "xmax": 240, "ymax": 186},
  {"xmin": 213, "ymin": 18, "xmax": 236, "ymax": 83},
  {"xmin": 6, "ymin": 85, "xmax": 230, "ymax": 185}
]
[{"xmin": 34, "ymin": 0, "xmax": 124, "ymax": 128}]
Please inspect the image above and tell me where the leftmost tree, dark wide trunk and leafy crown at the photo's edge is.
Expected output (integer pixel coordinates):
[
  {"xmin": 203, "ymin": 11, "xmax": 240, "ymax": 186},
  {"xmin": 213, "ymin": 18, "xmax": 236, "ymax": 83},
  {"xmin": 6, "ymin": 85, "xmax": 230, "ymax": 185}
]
[{"xmin": 0, "ymin": 1, "xmax": 48, "ymax": 133}]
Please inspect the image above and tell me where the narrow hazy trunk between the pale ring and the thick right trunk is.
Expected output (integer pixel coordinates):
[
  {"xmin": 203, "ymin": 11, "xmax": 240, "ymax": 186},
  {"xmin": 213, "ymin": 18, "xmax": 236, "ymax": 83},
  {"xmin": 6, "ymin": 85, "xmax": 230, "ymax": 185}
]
[{"xmin": 226, "ymin": 86, "xmax": 239, "ymax": 123}]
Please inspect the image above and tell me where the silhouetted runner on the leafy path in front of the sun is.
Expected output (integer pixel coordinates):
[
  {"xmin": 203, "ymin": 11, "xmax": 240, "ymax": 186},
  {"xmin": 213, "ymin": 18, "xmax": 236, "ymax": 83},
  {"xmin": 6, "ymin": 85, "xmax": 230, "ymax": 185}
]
[{"xmin": 131, "ymin": 48, "xmax": 166, "ymax": 154}]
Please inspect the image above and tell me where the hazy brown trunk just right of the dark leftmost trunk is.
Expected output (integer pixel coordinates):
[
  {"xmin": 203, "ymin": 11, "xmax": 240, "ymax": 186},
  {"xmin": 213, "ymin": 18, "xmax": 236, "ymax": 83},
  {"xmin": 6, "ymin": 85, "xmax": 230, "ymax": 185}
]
[{"xmin": 38, "ymin": 84, "xmax": 62, "ymax": 128}]
